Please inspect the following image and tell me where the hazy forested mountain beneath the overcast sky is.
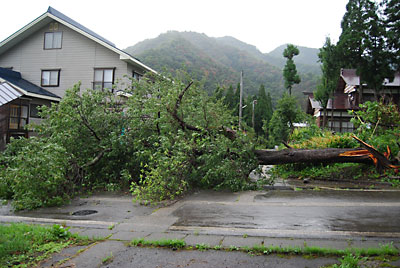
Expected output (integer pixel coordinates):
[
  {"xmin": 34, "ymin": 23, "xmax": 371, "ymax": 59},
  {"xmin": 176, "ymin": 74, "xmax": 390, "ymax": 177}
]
[{"xmin": 125, "ymin": 31, "xmax": 319, "ymax": 106}]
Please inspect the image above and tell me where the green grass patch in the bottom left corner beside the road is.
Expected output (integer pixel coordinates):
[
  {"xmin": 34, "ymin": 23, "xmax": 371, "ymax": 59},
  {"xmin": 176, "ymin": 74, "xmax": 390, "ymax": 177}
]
[{"xmin": 0, "ymin": 223, "xmax": 90, "ymax": 267}]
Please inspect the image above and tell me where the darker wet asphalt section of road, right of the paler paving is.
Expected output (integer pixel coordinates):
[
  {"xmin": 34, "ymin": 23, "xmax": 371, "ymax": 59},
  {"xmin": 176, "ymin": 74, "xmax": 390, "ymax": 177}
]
[{"xmin": 173, "ymin": 190, "xmax": 400, "ymax": 237}]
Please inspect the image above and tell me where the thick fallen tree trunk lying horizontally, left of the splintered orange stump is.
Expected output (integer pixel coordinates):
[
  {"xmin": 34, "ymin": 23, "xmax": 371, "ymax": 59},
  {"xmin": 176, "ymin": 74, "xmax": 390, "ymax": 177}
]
[{"xmin": 255, "ymin": 148, "xmax": 373, "ymax": 165}]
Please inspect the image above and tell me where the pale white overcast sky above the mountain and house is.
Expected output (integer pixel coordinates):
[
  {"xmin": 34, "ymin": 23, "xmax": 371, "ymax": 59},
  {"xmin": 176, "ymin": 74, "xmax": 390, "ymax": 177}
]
[{"xmin": 0, "ymin": 0, "xmax": 348, "ymax": 53}]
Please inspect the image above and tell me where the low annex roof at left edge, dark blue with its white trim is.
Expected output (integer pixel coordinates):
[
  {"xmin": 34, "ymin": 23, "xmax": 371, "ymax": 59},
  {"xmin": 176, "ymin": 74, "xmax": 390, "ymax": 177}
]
[{"xmin": 0, "ymin": 67, "xmax": 61, "ymax": 101}]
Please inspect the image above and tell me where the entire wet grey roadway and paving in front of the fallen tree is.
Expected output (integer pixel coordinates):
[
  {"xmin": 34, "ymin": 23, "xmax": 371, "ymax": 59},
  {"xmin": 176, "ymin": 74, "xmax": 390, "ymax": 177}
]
[{"xmin": 0, "ymin": 187, "xmax": 400, "ymax": 267}]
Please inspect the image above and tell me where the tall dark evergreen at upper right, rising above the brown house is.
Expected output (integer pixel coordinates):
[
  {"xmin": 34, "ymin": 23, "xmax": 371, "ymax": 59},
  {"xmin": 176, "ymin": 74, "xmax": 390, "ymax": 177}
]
[{"xmin": 337, "ymin": 0, "xmax": 394, "ymax": 102}]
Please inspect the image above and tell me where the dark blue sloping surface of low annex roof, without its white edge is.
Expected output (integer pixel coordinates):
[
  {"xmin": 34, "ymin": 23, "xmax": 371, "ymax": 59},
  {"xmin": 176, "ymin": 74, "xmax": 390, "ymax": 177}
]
[{"xmin": 0, "ymin": 67, "xmax": 60, "ymax": 98}]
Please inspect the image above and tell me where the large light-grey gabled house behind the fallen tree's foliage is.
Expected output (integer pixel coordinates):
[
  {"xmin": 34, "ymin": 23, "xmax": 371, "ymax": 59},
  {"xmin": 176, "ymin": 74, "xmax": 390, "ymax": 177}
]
[{"xmin": 0, "ymin": 7, "xmax": 155, "ymax": 147}]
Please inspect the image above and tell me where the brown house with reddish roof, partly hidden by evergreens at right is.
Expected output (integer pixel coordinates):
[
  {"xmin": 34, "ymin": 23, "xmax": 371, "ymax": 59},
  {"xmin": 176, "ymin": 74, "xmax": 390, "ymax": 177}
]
[{"xmin": 304, "ymin": 69, "xmax": 400, "ymax": 132}]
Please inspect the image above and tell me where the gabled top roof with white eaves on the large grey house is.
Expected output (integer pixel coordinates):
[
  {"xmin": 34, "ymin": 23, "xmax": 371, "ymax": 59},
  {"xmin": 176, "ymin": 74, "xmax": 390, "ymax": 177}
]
[{"xmin": 0, "ymin": 7, "xmax": 157, "ymax": 73}]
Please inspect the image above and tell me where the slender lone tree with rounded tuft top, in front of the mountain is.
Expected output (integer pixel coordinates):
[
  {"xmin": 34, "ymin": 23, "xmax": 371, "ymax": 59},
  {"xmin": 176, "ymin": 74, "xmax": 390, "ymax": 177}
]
[{"xmin": 283, "ymin": 44, "xmax": 301, "ymax": 95}]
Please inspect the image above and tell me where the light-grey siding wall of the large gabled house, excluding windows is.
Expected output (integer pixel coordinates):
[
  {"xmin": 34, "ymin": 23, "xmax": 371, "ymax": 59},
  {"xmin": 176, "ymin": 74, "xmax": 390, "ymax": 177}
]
[{"xmin": 0, "ymin": 20, "xmax": 136, "ymax": 97}]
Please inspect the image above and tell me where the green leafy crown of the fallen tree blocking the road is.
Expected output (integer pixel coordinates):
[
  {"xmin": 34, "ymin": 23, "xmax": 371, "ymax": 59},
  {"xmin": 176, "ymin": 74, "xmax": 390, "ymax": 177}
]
[{"xmin": 0, "ymin": 76, "xmax": 257, "ymax": 209}]
